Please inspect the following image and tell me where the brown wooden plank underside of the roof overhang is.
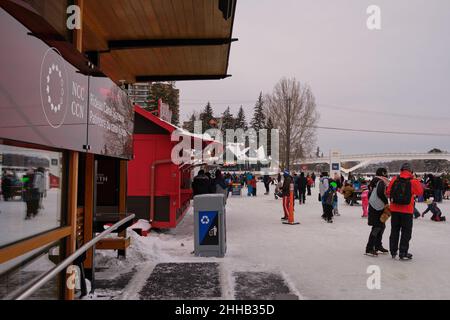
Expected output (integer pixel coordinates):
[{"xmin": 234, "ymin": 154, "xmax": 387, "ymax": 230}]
[{"xmin": 82, "ymin": 0, "xmax": 236, "ymax": 83}]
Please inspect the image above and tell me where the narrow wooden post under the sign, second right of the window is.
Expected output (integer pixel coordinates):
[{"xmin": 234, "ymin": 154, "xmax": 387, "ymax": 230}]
[{"xmin": 84, "ymin": 153, "xmax": 95, "ymax": 269}]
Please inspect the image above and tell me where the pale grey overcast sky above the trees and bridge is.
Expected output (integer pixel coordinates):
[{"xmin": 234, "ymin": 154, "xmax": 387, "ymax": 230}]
[{"xmin": 177, "ymin": 0, "xmax": 450, "ymax": 154}]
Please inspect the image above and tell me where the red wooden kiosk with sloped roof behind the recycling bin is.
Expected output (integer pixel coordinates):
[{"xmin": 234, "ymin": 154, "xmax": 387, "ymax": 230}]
[{"xmin": 127, "ymin": 106, "xmax": 209, "ymax": 229}]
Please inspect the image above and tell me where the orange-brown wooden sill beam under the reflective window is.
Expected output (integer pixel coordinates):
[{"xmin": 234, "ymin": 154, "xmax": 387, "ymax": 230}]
[{"xmin": 0, "ymin": 227, "xmax": 72, "ymax": 263}]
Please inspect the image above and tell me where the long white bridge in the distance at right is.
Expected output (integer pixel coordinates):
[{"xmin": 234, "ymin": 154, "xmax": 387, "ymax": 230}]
[{"xmin": 294, "ymin": 152, "xmax": 450, "ymax": 173}]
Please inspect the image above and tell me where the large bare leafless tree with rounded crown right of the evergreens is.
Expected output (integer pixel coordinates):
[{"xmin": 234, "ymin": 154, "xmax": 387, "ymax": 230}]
[{"xmin": 266, "ymin": 78, "xmax": 320, "ymax": 169}]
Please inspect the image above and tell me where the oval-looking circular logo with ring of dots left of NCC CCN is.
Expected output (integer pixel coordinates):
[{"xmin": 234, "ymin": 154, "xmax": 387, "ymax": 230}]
[{"xmin": 40, "ymin": 48, "xmax": 68, "ymax": 128}]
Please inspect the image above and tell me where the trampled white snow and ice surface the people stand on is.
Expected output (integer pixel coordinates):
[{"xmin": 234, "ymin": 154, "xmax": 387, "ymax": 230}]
[{"xmin": 92, "ymin": 185, "xmax": 450, "ymax": 299}]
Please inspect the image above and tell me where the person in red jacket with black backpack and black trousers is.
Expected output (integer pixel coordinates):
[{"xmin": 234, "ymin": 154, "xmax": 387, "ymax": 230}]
[{"xmin": 386, "ymin": 163, "xmax": 423, "ymax": 260}]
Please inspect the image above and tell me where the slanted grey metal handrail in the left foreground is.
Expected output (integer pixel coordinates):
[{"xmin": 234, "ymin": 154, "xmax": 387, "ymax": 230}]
[{"xmin": 4, "ymin": 214, "xmax": 135, "ymax": 300}]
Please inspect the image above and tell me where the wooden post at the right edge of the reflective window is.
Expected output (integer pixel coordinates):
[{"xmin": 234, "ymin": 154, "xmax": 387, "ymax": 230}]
[{"xmin": 65, "ymin": 151, "xmax": 79, "ymax": 300}]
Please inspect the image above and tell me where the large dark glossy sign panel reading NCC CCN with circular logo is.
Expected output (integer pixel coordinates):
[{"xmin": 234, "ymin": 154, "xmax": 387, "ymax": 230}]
[{"xmin": 0, "ymin": 8, "xmax": 134, "ymax": 159}]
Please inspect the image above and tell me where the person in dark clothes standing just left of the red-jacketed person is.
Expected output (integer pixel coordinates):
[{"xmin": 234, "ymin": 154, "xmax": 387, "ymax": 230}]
[{"xmin": 366, "ymin": 168, "xmax": 389, "ymax": 257}]
